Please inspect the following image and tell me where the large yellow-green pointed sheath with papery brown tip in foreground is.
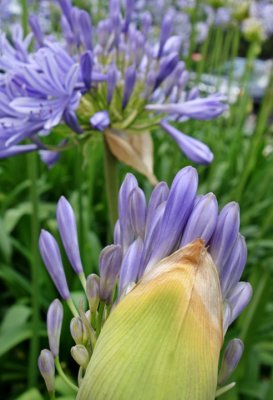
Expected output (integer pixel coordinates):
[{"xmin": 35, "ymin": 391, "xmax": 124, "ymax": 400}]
[{"xmin": 77, "ymin": 240, "xmax": 223, "ymax": 400}]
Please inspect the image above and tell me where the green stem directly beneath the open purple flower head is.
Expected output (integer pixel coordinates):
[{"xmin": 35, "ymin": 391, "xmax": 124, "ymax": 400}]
[{"xmin": 104, "ymin": 139, "xmax": 119, "ymax": 232}]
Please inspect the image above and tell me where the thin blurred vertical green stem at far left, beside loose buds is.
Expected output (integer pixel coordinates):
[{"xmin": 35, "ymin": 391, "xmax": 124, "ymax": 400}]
[{"xmin": 27, "ymin": 154, "xmax": 40, "ymax": 387}]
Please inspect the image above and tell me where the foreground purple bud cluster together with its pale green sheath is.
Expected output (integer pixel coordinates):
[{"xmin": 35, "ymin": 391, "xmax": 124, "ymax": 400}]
[{"xmin": 38, "ymin": 167, "xmax": 252, "ymax": 400}]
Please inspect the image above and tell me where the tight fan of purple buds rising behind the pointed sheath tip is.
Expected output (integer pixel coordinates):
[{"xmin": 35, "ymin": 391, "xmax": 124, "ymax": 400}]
[{"xmin": 111, "ymin": 167, "xmax": 252, "ymax": 327}]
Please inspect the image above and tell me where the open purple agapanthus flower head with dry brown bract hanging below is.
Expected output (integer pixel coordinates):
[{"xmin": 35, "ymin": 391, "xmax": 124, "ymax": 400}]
[{"xmin": 0, "ymin": 0, "xmax": 227, "ymax": 178}]
